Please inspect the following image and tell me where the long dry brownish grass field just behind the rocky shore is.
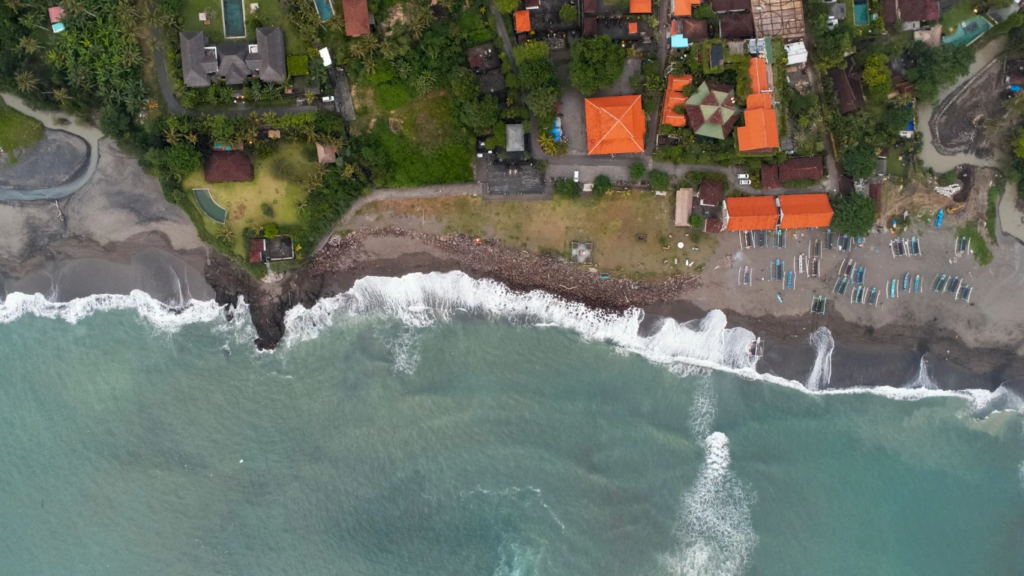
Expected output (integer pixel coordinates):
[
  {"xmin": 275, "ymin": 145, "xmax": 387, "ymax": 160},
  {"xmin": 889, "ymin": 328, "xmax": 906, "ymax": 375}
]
[{"xmin": 356, "ymin": 191, "xmax": 718, "ymax": 279}]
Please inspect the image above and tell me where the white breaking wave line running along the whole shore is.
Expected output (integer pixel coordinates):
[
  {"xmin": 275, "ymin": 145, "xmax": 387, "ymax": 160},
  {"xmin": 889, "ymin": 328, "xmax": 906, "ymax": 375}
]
[{"xmin": 0, "ymin": 272, "xmax": 1024, "ymax": 416}]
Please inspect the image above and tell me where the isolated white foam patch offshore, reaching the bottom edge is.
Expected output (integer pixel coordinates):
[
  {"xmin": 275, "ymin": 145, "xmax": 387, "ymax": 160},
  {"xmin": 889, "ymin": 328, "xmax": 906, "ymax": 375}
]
[{"xmin": 662, "ymin": 433, "xmax": 758, "ymax": 576}]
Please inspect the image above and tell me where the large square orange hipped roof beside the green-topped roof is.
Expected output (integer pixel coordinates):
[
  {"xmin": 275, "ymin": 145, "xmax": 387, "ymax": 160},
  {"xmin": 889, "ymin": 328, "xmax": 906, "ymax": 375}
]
[{"xmin": 584, "ymin": 94, "xmax": 647, "ymax": 155}]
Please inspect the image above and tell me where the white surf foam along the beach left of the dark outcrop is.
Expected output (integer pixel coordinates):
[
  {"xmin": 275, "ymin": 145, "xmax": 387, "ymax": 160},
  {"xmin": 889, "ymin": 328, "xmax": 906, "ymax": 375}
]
[{"xmin": 0, "ymin": 290, "xmax": 226, "ymax": 332}]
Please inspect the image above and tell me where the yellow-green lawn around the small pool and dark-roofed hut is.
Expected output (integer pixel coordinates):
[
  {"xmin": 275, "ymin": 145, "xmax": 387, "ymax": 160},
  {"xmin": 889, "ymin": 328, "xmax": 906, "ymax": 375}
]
[{"xmin": 182, "ymin": 143, "xmax": 317, "ymax": 255}]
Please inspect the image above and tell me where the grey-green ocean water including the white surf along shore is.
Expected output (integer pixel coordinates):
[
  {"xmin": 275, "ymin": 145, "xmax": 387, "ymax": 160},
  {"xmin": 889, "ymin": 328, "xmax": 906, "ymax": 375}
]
[{"xmin": 0, "ymin": 273, "xmax": 1024, "ymax": 576}]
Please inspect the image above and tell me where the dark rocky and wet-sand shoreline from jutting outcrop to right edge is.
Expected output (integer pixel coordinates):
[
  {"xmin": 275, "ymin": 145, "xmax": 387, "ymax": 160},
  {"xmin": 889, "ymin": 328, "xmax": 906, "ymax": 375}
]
[{"xmin": 195, "ymin": 224, "xmax": 1024, "ymax": 390}]
